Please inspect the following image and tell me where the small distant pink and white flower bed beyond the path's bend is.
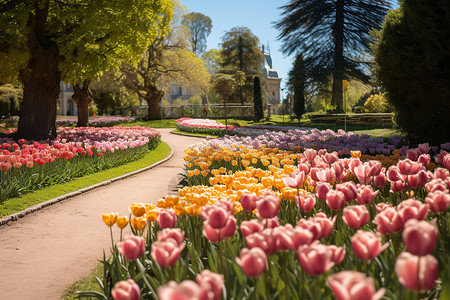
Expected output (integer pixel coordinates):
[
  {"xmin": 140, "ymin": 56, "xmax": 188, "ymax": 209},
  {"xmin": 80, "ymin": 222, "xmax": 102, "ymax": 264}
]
[{"xmin": 177, "ymin": 118, "xmax": 234, "ymax": 136}]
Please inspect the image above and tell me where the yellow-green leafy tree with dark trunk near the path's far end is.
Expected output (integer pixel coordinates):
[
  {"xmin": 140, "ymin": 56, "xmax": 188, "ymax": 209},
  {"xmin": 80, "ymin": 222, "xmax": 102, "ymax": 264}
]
[{"xmin": 122, "ymin": 4, "xmax": 210, "ymax": 120}]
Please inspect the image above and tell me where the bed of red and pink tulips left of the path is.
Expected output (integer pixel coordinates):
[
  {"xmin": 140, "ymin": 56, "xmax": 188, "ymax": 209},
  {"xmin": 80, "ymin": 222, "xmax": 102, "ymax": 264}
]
[{"xmin": 0, "ymin": 126, "xmax": 161, "ymax": 203}]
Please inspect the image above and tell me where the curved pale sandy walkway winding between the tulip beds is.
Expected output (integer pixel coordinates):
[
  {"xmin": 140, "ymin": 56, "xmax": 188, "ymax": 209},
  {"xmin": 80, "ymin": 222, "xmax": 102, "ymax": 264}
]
[{"xmin": 0, "ymin": 129, "xmax": 199, "ymax": 300}]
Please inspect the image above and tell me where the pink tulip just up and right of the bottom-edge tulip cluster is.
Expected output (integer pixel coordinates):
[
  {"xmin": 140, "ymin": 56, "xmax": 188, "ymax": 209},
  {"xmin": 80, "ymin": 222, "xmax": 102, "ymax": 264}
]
[{"xmin": 236, "ymin": 247, "xmax": 267, "ymax": 277}]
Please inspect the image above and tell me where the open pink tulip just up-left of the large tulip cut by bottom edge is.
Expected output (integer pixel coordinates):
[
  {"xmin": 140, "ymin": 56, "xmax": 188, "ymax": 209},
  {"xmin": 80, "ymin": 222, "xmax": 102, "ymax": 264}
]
[{"xmin": 297, "ymin": 241, "xmax": 334, "ymax": 275}]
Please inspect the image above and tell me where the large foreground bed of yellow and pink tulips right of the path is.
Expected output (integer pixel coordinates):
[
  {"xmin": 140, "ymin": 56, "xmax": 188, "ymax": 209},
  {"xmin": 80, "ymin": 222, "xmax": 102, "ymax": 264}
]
[{"xmin": 93, "ymin": 132, "xmax": 450, "ymax": 299}]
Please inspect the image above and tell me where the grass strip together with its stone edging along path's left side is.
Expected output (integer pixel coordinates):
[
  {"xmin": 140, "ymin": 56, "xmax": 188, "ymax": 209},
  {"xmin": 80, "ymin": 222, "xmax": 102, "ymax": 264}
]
[{"xmin": 0, "ymin": 142, "xmax": 173, "ymax": 226}]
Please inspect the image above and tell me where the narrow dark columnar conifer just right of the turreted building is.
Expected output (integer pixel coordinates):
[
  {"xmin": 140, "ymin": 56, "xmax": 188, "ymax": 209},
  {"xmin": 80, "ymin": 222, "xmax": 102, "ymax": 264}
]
[{"xmin": 288, "ymin": 53, "xmax": 306, "ymax": 120}]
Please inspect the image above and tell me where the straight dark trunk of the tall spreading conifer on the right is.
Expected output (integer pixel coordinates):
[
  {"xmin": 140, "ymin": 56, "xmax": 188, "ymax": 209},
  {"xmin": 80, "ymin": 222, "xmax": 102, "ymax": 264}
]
[{"xmin": 331, "ymin": 0, "xmax": 345, "ymax": 112}]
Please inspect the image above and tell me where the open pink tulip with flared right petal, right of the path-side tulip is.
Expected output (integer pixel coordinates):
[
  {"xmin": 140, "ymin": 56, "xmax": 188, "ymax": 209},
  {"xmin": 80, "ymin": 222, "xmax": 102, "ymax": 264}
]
[{"xmin": 151, "ymin": 238, "xmax": 186, "ymax": 267}]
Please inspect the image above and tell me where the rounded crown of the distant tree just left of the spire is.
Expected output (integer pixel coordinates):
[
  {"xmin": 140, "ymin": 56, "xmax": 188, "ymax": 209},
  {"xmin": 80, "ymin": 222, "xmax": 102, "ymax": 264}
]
[{"xmin": 221, "ymin": 27, "xmax": 262, "ymax": 75}]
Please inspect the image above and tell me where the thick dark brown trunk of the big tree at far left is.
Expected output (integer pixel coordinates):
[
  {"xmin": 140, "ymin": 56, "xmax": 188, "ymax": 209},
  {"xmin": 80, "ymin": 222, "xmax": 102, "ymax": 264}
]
[{"xmin": 17, "ymin": 4, "xmax": 61, "ymax": 140}]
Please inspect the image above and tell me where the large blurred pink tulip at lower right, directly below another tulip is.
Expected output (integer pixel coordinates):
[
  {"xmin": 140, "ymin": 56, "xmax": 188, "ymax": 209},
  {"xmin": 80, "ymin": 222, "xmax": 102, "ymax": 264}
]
[{"xmin": 395, "ymin": 252, "xmax": 438, "ymax": 292}]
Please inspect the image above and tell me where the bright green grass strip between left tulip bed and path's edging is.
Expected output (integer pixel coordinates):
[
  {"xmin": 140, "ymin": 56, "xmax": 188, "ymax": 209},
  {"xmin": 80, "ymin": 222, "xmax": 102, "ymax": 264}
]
[{"xmin": 0, "ymin": 142, "xmax": 171, "ymax": 217}]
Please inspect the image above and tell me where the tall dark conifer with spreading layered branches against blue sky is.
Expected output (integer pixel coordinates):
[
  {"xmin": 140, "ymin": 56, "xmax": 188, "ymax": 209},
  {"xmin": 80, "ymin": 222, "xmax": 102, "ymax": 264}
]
[{"xmin": 275, "ymin": 0, "xmax": 392, "ymax": 111}]
